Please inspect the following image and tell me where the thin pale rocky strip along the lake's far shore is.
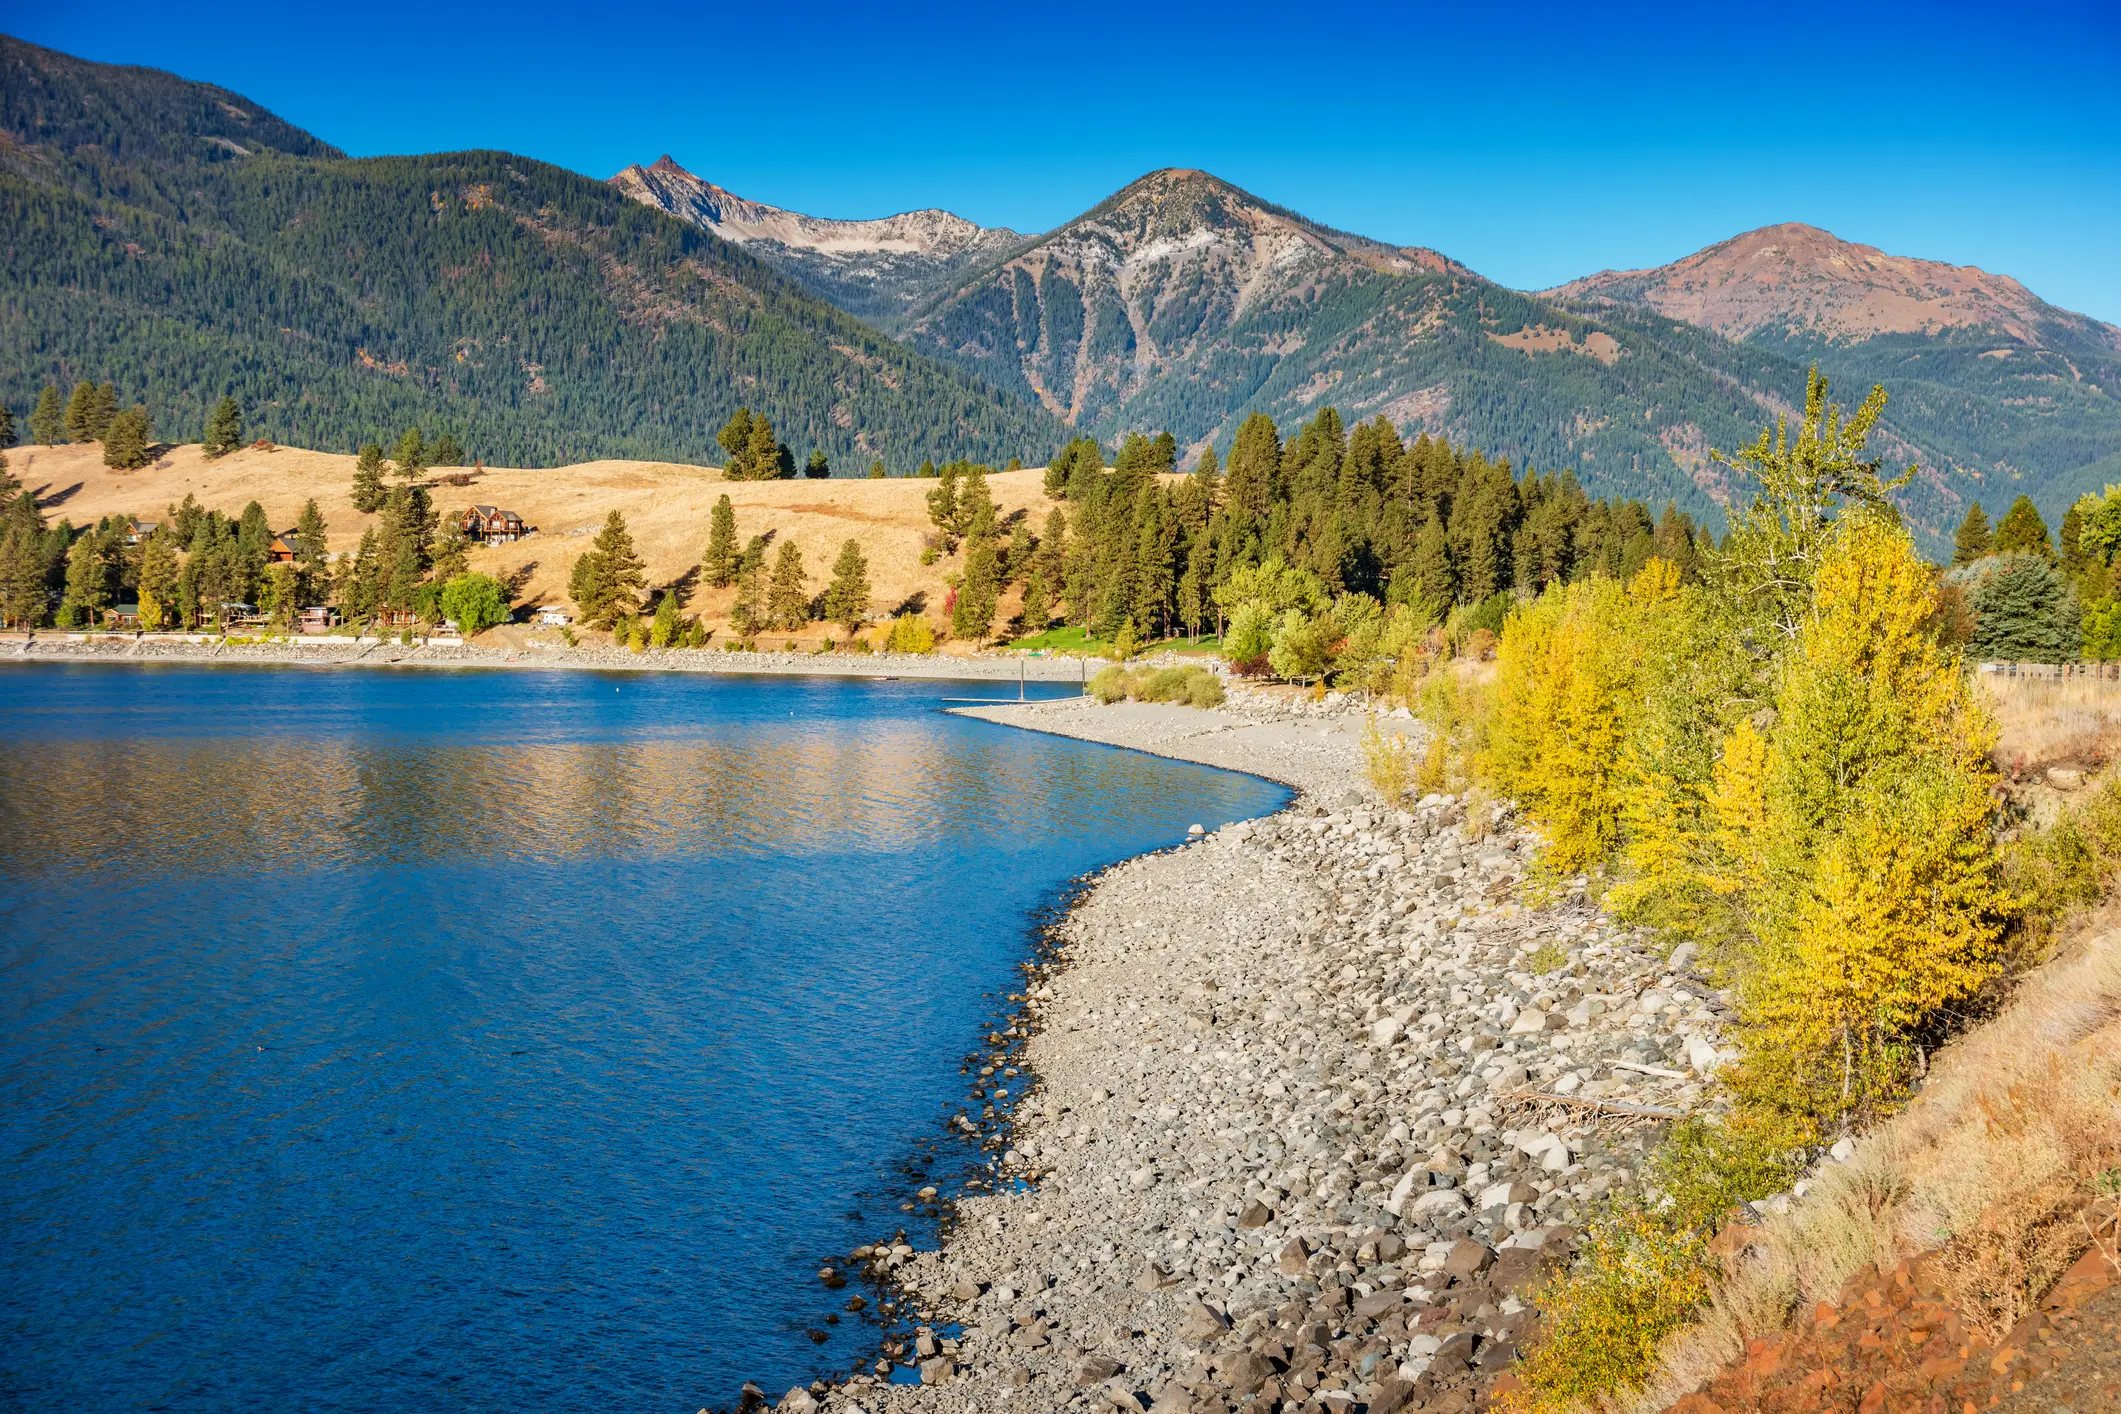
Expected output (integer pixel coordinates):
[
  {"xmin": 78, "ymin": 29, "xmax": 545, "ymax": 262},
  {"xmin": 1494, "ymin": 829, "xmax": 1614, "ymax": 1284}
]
[{"xmin": 0, "ymin": 632, "xmax": 1097, "ymax": 683}]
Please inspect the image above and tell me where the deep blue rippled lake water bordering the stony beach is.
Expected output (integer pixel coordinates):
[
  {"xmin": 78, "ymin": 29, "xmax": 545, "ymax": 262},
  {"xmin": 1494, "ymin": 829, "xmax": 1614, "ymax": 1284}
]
[{"xmin": 0, "ymin": 666, "xmax": 1283, "ymax": 1414}]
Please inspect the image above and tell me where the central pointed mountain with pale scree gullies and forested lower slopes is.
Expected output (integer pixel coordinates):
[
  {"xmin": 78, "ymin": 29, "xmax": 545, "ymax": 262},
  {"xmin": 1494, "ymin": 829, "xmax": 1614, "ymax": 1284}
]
[{"xmin": 906, "ymin": 170, "xmax": 1803, "ymax": 513}]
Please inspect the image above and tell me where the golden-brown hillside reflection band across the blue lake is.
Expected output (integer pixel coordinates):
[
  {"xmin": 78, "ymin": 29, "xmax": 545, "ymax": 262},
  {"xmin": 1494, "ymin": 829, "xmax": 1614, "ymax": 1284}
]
[{"xmin": 0, "ymin": 721, "xmax": 1204, "ymax": 876}]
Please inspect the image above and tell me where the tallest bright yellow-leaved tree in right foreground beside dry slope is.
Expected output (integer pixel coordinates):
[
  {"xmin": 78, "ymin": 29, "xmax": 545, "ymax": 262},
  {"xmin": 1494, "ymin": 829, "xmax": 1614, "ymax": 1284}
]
[{"xmin": 1714, "ymin": 517, "xmax": 2015, "ymax": 1119}]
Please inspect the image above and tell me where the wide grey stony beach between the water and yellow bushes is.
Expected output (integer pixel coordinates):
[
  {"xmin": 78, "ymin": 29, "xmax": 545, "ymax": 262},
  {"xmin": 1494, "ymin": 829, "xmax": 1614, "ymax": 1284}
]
[{"xmin": 753, "ymin": 689, "xmax": 1726, "ymax": 1414}]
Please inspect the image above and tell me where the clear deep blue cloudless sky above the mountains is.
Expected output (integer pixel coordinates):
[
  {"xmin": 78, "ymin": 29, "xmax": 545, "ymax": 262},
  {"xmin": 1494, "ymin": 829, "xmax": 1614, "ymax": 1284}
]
[{"xmin": 16, "ymin": 0, "xmax": 2121, "ymax": 322}]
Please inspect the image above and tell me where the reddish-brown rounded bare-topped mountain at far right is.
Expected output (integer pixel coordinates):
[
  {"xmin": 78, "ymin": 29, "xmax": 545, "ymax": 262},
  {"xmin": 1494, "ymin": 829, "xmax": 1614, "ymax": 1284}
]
[{"xmin": 1542, "ymin": 223, "xmax": 2121, "ymax": 524}]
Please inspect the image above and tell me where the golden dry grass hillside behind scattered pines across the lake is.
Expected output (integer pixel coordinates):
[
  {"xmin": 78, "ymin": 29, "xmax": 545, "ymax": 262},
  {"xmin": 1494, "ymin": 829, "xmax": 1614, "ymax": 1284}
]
[{"xmin": 8, "ymin": 443, "xmax": 1052, "ymax": 635}]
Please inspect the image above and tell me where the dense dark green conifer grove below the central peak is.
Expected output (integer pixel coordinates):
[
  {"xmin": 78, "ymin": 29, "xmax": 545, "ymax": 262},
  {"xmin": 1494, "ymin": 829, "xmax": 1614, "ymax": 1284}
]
[{"xmin": 967, "ymin": 407, "xmax": 1703, "ymax": 661}]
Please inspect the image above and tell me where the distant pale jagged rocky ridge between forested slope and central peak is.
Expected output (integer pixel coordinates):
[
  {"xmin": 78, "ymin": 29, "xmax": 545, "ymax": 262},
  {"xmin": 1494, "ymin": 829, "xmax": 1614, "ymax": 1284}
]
[{"xmin": 611, "ymin": 153, "xmax": 1029, "ymax": 333}]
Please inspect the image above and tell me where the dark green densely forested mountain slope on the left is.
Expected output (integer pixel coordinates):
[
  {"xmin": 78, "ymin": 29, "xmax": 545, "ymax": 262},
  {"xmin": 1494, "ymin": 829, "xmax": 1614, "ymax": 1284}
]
[{"xmin": 0, "ymin": 38, "xmax": 1065, "ymax": 471}]
